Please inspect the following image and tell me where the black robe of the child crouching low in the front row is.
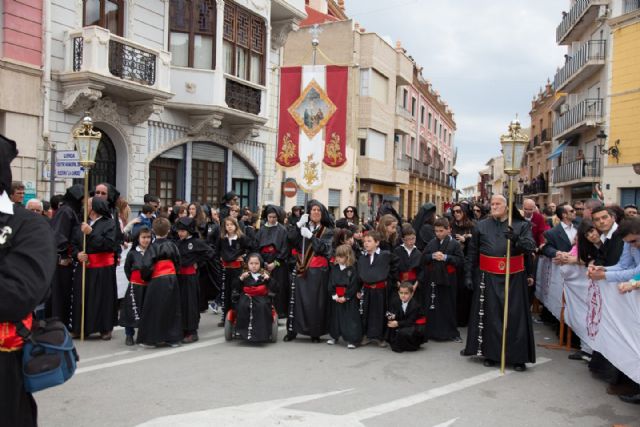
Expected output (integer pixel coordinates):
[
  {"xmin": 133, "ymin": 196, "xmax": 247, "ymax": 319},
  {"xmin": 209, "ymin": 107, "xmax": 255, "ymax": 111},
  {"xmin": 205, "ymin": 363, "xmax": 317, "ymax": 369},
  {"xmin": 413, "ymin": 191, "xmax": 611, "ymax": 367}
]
[{"xmin": 388, "ymin": 298, "xmax": 424, "ymax": 353}]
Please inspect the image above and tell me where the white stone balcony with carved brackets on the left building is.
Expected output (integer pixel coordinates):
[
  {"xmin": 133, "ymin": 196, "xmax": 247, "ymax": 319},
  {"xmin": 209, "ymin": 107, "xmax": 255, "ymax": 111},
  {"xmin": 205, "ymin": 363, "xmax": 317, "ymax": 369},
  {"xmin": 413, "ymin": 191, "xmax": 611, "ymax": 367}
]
[{"xmin": 60, "ymin": 26, "xmax": 173, "ymax": 124}]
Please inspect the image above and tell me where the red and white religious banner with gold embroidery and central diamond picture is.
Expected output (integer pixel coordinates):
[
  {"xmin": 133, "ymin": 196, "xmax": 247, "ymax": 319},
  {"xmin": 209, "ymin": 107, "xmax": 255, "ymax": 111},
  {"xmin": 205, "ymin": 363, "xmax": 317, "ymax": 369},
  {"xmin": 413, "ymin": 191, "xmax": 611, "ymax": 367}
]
[{"xmin": 276, "ymin": 65, "xmax": 348, "ymax": 191}]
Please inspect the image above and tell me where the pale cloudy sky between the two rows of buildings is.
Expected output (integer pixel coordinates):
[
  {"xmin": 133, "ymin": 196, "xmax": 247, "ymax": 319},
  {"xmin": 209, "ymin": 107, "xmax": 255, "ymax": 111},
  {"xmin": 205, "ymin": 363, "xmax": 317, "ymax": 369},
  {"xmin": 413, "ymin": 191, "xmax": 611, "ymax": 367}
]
[{"xmin": 345, "ymin": 0, "xmax": 569, "ymax": 188}]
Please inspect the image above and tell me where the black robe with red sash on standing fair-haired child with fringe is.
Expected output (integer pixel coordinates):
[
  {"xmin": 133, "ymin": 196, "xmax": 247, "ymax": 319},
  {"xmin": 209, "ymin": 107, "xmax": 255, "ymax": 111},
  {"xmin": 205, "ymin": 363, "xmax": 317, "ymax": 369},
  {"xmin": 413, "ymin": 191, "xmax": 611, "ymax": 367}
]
[{"xmin": 329, "ymin": 264, "xmax": 362, "ymax": 344}]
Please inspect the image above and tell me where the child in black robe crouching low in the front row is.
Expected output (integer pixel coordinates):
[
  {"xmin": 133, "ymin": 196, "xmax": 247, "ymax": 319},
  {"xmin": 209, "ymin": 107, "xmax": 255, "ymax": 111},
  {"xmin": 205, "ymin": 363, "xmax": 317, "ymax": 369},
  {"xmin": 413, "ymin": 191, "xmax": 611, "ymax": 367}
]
[{"xmin": 387, "ymin": 282, "xmax": 424, "ymax": 353}]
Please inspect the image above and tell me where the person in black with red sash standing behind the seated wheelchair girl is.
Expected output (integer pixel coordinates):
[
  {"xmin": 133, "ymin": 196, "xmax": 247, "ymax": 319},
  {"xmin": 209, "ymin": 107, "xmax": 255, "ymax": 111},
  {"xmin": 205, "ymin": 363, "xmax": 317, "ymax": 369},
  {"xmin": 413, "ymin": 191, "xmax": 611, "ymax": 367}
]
[{"xmin": 255, "ymin": 205, "xmax": 291, "ymax": 318}]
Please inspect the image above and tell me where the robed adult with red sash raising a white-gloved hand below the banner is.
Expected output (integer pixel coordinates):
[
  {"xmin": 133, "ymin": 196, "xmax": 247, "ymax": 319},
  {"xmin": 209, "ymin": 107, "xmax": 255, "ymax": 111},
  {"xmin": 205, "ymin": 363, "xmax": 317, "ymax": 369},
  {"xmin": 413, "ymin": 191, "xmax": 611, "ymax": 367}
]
[{"xmin": 284, "ymin": 200, "xmax": 334, "ymax": 343}]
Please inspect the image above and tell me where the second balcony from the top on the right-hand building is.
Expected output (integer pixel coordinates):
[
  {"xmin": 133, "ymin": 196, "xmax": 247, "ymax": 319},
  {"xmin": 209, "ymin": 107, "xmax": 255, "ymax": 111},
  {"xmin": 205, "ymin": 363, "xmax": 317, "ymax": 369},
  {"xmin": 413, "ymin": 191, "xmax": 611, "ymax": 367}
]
[{"xmin": 553, "ymin": 40, "xmax": 607, "ymax": 92}]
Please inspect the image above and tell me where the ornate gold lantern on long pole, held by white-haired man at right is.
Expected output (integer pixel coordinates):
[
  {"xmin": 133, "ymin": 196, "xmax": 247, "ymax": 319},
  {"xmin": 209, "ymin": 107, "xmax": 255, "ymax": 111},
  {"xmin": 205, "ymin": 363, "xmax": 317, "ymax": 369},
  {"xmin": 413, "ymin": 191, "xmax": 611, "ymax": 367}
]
[{"xmin": 500, "ymin": 118, "xmax": 529, "ymax": 374}]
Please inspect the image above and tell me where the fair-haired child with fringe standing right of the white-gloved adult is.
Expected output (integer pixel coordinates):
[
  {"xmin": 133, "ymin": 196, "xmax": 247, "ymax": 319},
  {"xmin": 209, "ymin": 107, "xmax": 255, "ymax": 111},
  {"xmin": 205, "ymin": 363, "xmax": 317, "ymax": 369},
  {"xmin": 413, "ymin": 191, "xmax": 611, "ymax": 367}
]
[{"xmin": 327, "ymin": 244, "xmax": 362, "ymax": 350}]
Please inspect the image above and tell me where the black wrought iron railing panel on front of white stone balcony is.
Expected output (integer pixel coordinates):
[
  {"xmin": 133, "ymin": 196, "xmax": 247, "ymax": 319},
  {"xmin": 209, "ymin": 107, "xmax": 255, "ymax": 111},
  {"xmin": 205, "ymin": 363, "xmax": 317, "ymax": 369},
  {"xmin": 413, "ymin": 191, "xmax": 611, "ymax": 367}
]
[{"xmin": 109, "ymin": 39, "xmax": 157, "ymax": 86}]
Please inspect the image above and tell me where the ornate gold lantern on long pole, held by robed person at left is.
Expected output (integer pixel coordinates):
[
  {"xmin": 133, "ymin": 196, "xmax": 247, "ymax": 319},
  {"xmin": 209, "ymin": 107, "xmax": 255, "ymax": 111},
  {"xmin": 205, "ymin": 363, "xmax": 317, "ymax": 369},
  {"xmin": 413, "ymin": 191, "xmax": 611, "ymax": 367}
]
[{"xmin": 73, "ymin": 113, "xmax": 102, "ymax": 341}]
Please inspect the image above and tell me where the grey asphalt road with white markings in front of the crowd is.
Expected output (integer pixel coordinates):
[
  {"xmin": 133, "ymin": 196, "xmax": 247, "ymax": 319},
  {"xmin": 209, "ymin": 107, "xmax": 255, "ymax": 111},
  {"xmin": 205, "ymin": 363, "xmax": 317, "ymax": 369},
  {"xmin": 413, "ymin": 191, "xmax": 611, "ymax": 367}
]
[{"xmin": 36, "ymin": 313, "xmax": 640, "ymax": 427}]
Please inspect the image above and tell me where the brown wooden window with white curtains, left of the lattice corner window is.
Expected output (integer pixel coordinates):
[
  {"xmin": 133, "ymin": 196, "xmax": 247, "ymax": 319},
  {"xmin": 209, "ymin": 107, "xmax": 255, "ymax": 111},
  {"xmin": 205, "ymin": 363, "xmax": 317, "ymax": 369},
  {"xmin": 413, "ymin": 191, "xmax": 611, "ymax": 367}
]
[{"xmin": 169, "ymin": 0, "xmax": 216, "ymax": 69}]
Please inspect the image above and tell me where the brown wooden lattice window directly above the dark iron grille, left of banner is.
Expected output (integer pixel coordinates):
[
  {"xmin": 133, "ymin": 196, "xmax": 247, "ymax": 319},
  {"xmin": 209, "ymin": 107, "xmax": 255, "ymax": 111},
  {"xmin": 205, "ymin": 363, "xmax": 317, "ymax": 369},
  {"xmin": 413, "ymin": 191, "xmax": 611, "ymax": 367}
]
[{"xmin": 222, "ymin": 1, "xmax": 266, "ymax": 84}]
